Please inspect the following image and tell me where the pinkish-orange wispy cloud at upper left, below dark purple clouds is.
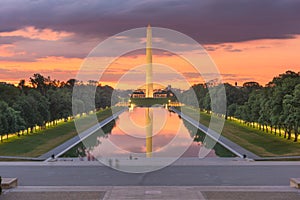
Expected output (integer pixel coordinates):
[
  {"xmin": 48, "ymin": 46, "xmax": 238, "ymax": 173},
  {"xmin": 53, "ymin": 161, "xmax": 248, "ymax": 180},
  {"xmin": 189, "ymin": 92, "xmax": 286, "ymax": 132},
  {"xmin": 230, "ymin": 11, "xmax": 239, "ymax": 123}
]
[{"xmin": 0, "ymin": 26, "xmax": 73, "ymax": 41}]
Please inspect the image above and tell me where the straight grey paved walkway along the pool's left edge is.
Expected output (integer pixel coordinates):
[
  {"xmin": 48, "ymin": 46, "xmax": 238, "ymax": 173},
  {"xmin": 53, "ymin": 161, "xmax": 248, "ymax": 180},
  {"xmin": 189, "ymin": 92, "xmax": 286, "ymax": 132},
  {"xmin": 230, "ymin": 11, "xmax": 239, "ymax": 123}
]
[{"xmin": 38, "ymin": 108, "xmax": 127, "ymax": 160}]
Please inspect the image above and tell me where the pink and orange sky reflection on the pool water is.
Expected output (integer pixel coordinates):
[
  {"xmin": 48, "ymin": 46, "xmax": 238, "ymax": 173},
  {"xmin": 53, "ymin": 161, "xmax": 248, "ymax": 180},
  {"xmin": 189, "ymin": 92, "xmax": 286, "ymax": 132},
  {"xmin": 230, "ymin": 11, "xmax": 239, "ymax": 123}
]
[{"xmin": 91, "ymin": 107, "xmax": 216, "ymax": 157}]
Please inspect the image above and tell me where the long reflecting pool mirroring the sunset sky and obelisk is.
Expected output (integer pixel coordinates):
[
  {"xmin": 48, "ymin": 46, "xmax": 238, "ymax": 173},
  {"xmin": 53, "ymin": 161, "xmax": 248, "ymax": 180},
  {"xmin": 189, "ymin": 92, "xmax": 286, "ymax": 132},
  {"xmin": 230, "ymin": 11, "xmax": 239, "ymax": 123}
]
[{"xmin": 63, "ymin": 107, "xmax": 235, "ymax": 159}]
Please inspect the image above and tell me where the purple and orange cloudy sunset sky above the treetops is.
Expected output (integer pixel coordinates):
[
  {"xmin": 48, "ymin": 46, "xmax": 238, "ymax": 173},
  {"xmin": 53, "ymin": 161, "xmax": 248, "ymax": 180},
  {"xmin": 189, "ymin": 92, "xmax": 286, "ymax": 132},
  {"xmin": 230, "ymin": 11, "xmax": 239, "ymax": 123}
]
[{"xmin": 0, "ymin": 0, "xmax": 300, "ymax": 88}]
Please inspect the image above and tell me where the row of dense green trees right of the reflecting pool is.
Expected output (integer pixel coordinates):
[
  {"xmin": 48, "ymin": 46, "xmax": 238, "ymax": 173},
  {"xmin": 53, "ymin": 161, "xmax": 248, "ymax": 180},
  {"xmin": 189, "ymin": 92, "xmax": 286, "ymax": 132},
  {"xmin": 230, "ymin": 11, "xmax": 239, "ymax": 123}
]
[{"xmin": 183, "ymin": 71, "xmax": 300, "ymax": 142}]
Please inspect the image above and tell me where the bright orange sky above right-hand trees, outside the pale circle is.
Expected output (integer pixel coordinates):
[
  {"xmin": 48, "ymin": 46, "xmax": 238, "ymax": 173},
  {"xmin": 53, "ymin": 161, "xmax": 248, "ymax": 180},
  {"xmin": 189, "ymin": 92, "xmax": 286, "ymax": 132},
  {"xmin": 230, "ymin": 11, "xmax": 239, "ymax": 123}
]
[{"xmin": 206, "ymin": 35, "xmax": 300, "ymax": 85}]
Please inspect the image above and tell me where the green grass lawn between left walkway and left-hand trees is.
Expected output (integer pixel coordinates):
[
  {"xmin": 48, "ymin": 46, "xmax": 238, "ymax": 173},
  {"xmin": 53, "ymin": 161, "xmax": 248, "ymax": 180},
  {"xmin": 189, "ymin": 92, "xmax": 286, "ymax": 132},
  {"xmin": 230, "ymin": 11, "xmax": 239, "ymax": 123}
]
[{"xmin": 0, "ymin": 108, "xmax": 121, "ymax": 157}]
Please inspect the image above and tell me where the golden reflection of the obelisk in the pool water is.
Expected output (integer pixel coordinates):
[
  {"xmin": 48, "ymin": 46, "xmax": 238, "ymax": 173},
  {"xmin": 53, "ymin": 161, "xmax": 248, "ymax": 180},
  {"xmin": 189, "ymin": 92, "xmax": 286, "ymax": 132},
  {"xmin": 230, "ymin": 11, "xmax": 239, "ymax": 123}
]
[{"xmin": 146, "ymin": 108, "xmax": 153, "ymax": 158}]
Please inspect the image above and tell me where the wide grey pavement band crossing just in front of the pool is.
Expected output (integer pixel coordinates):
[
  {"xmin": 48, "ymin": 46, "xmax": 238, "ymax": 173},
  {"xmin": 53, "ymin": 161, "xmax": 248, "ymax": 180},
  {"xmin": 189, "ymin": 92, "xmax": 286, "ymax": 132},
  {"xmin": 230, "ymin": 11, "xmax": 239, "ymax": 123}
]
[{"xmin": 0, "ymin": 159, "xmax": 300, "ymax": 186}]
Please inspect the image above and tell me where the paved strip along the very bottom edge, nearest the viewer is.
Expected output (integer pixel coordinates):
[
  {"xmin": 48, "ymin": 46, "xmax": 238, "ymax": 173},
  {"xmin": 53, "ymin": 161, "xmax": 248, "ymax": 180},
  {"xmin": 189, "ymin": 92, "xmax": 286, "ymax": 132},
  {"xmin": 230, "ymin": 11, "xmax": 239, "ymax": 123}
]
[{"xmin": 1, "ymin": 186, "xmax": 300, "ymax": 200}]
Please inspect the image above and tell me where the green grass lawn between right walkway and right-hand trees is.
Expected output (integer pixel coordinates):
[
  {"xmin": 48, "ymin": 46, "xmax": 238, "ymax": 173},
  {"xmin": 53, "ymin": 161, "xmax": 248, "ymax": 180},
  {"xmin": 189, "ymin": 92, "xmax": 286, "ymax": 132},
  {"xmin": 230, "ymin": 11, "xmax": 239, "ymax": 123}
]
[{"xmin": 179, "ymin": 107, "xmax": 300, "ymax": 157}]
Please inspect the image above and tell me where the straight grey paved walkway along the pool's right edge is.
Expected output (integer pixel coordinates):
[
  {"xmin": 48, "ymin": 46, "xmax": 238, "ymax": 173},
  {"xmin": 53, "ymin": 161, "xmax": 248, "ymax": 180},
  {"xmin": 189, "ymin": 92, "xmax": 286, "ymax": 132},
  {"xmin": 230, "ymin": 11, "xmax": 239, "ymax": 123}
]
[{"xmin": 170, "ymin": 107, "xmax": 261, "ymax": 160}]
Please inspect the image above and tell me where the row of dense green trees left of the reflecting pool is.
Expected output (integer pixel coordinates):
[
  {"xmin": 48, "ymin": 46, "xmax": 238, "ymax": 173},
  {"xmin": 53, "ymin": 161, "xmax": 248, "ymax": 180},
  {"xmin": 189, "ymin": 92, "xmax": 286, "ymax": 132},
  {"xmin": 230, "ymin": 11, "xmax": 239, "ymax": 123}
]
[{"xmin": 0, "ymin": 74, "xmax": 113, "ymax": 141}]
